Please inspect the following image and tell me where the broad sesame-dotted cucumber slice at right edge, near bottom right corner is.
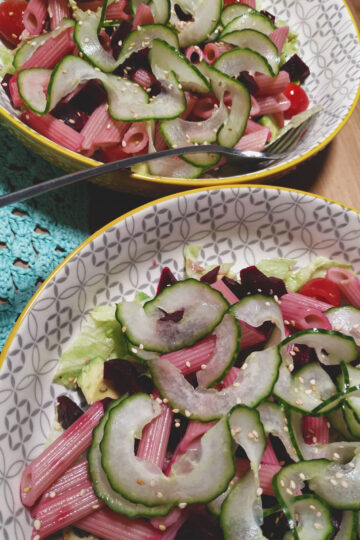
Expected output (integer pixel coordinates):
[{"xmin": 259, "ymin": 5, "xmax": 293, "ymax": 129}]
[{"xmin": 309, "ymin": 449, "xmax": 360, "ymax": 510}]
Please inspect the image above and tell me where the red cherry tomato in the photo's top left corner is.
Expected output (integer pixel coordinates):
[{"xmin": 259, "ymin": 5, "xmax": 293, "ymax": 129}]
[{"xmin": 0, "ymin": 0, "xmax": 27, "ymax": 45}]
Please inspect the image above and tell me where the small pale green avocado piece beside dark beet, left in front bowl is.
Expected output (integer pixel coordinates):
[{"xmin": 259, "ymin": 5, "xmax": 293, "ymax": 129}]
[{"xmin": 77, "ymin": 356, "xmax": 119, "ymax": 405}]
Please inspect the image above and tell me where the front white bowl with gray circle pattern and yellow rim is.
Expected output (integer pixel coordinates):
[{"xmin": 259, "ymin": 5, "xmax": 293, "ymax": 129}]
[{"xmin": 0, "ymin": 186, "xmax": 360, "ymax": 540}]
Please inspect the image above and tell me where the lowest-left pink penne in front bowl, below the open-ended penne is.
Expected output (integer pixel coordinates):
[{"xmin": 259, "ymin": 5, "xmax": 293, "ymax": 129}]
[{"xmin": 32, "ymin": 479, "xmax": 105, "ymax": 540}]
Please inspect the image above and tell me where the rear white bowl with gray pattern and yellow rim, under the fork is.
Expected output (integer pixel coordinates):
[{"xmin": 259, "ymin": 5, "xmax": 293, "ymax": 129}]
[{"xmin": 0, "ymin": 0, "xmax": 360, "ymax": 196}]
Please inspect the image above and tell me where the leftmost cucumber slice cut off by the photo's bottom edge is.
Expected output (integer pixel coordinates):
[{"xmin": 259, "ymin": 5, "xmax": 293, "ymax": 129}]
[{"xmin": 220, "ymin": 471, "xmax": 266, "ymax": 540}]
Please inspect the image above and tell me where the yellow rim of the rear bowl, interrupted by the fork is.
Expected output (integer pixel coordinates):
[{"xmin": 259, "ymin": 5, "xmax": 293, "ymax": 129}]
[{"xmin": 0, "ymin": 0, "xmax": 360, "ymax": 187}]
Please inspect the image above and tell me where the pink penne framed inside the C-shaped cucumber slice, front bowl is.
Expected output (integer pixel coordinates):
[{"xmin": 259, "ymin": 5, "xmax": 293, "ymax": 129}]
[{"xmin": 136, "ymin": 396, "xmax": 173, "ymax": 468}]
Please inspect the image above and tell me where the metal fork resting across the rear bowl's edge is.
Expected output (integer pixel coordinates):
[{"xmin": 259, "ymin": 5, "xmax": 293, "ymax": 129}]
[{"xmin": 0, "ymin": 111, "xmax": 318, "ymax": 208}]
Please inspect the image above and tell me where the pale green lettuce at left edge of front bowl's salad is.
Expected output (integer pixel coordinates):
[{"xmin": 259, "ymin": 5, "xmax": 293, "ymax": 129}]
[{"xmin": 54, "ymin": 306, "xmax": 127, "ymax": 389}]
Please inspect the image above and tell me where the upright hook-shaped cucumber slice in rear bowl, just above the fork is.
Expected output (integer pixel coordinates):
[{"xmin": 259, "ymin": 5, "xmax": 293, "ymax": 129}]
[{"xmin": 198, "ymin": 62, "xmax": 251, "ymax": 148}]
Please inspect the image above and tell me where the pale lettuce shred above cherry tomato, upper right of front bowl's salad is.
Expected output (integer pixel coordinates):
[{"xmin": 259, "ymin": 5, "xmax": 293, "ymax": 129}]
[{"xmin": 256, "ymin": 257, "xmax": 351, "ymax": 292}]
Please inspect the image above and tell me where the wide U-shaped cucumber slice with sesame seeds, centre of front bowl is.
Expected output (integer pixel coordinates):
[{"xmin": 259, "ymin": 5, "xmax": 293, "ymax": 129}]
[{"xmin": 148, "ymin": 347, "xmax": 280, "ymax": 422}]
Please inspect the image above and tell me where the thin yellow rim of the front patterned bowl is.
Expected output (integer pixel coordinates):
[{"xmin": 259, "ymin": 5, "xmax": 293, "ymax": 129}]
[{"xmin": 0, "ymin": 184, "xmax": 360, "ymax": 371}]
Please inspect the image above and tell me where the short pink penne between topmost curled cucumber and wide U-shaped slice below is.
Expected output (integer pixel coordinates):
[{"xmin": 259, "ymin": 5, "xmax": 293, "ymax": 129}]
[{"xmin": 163, "ymin": 335, "xmax": 216, "ymax": 375}]
